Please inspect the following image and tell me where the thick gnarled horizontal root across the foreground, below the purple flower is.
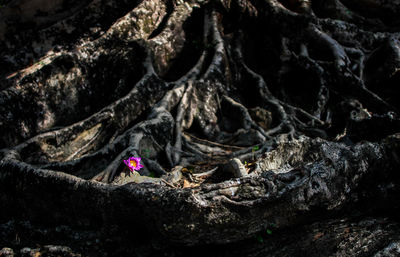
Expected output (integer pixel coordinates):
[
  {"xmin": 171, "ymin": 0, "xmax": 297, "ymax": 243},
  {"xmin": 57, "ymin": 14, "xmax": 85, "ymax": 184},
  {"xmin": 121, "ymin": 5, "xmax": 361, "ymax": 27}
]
[{"xmin": 0, "ymin": 135, "xmax": 400, "ymax": 245}]
